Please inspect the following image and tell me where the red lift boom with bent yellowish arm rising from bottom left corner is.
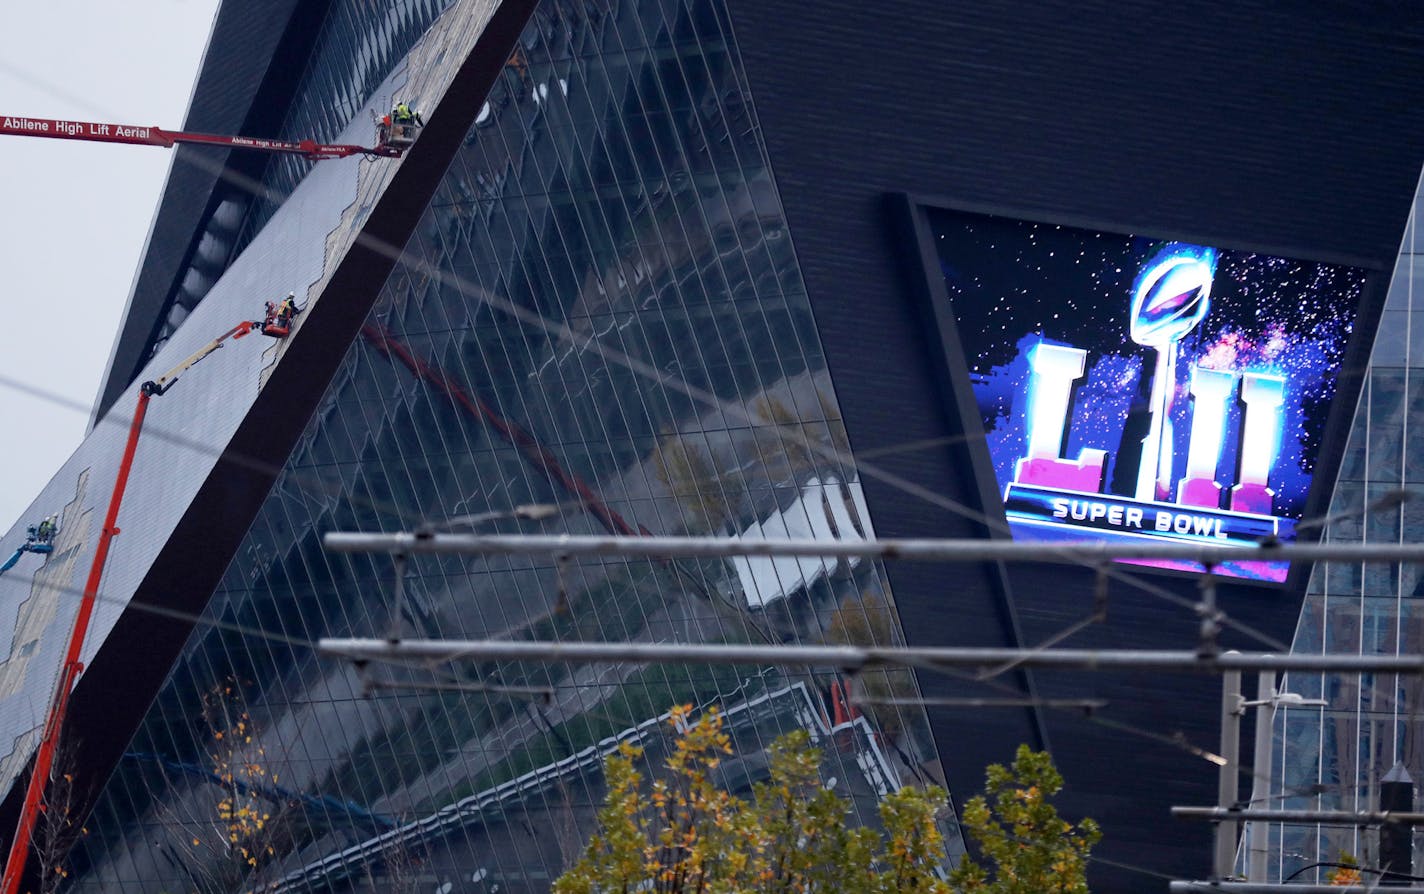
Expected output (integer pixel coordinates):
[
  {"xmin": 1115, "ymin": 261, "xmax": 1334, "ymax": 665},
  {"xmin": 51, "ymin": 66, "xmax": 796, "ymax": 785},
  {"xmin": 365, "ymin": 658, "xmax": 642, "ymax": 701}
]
[{"xmin": 0, "ymin": 314, "xmax": 277, "ymax": 894}]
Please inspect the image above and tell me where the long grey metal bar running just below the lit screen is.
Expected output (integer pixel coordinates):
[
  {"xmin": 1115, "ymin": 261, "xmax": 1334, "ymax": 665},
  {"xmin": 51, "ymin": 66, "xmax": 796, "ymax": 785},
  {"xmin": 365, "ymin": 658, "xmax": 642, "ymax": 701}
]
[{"xmin": 318, "ymin": 639, "xmax": 1424, "ymax": 673}]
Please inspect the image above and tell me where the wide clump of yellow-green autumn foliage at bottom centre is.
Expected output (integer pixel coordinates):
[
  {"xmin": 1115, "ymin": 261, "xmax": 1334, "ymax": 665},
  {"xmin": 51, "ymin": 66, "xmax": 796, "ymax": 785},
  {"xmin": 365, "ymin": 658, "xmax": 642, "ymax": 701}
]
[{"xmin": 554, "ymin": 706, "xmax": 950, "ymax": 894}]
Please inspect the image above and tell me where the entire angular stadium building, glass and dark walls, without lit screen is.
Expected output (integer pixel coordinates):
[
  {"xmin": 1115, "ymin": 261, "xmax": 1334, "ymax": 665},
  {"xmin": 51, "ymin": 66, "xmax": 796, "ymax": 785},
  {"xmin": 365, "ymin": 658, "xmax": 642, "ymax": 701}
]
[{"xmin": 0, "ymin": 0, "xmax": 1424, "ymax": 894}]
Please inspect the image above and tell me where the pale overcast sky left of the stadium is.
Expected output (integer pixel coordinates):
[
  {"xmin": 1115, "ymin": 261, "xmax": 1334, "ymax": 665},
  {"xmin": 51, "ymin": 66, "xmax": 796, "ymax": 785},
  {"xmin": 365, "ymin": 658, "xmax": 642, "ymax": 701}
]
[{"xmin": 0, "ymin": 0, "xmax": 218, "ymax": 526}]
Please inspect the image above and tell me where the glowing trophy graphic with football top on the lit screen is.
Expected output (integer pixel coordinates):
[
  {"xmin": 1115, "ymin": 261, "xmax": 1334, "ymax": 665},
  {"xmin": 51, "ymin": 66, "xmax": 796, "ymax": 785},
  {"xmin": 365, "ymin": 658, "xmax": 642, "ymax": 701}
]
[{"xmin": 1129, "ymin": 252, "xmax": 1216, "ymax": 500}]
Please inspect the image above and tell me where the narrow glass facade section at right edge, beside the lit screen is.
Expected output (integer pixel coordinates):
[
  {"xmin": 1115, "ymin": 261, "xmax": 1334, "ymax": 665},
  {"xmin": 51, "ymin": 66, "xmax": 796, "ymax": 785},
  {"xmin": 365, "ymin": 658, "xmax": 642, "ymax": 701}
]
[{"xmin": 1270, "ymin": 180, "xmax": 1424, "ymax": 880}]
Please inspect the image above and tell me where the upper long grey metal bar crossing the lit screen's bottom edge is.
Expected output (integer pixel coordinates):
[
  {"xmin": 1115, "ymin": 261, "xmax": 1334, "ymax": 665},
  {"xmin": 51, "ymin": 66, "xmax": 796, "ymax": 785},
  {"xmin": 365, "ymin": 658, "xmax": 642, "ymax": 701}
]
[{"xmin": 322, "ymin": 531, "xmax": 1424, "ymax": 567}]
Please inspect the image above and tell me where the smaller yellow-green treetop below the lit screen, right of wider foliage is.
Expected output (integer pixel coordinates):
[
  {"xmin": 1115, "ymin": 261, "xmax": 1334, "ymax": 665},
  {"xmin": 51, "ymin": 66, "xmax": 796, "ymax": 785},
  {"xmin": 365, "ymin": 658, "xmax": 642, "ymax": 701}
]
[{"xmin": 950, "ymin": 745, "xmax": 1102, "ymax": 894}]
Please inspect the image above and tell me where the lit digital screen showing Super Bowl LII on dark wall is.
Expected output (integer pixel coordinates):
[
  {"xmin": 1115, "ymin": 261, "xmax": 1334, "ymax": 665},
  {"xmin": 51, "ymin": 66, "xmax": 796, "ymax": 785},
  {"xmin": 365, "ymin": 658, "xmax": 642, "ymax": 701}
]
[{"xmin": 928, "ymin": 209, "xmax": 1366, "ymax": 582}]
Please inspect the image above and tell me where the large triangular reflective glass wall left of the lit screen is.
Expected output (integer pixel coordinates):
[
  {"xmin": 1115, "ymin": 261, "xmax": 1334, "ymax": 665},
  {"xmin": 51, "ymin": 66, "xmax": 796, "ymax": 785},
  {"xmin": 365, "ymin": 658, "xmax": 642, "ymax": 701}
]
[{"xmin": 70, "ymin": 0, "xmax": 961, "ymax": 894}]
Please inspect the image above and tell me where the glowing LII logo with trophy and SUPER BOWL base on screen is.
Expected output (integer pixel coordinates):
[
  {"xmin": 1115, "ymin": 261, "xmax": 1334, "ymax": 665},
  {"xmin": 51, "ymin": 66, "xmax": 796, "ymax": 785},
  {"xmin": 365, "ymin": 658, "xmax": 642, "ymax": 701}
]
[{"xmin": 1004, "ymin": 246, "xmax": 1286, "ymax": 542}]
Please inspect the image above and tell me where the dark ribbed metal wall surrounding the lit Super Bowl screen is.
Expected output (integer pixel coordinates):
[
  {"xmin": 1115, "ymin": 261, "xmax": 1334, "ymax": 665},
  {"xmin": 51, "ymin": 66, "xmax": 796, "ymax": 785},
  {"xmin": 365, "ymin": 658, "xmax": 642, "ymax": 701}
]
[{"xmin": 732, "ymin": 0, "xmax": 1424, "ymax": 891}]
